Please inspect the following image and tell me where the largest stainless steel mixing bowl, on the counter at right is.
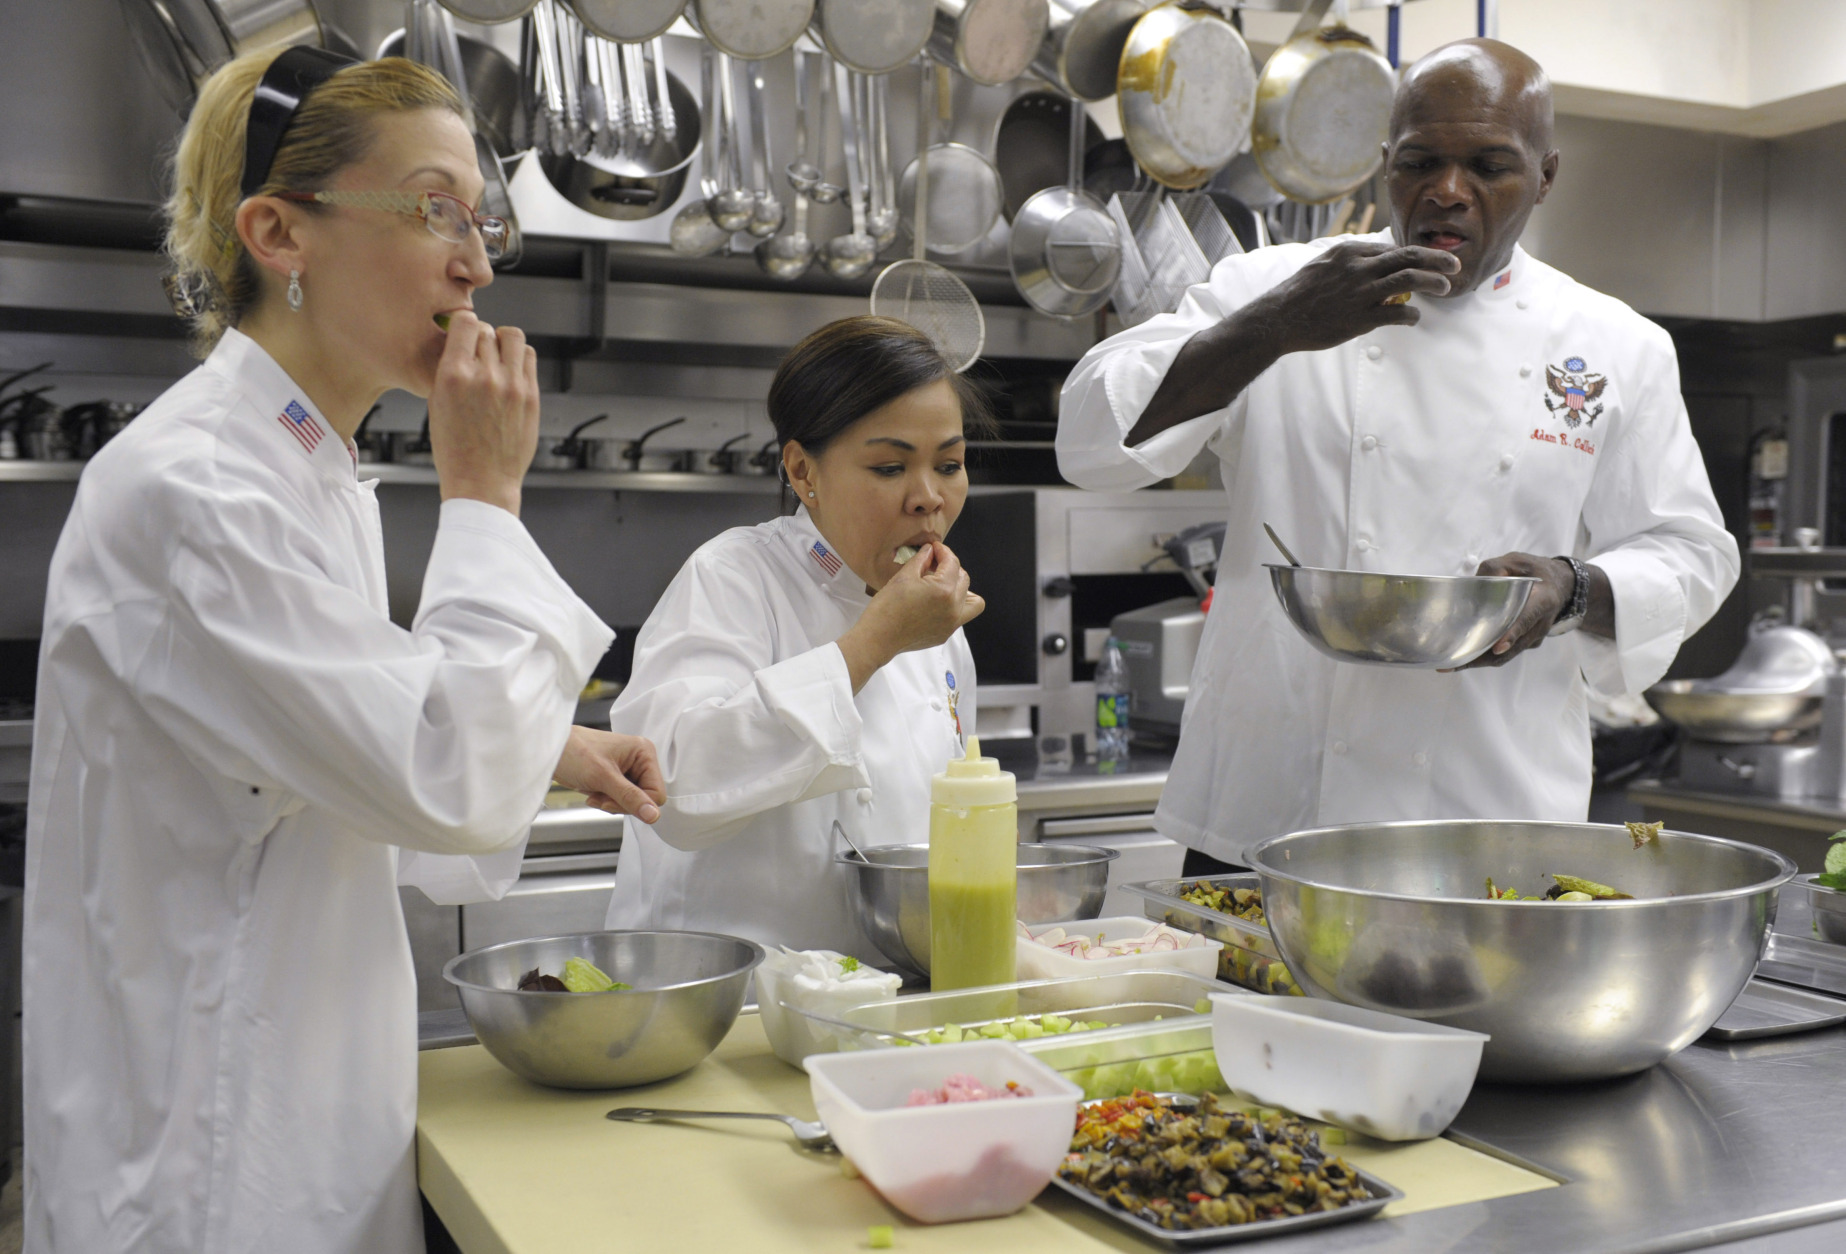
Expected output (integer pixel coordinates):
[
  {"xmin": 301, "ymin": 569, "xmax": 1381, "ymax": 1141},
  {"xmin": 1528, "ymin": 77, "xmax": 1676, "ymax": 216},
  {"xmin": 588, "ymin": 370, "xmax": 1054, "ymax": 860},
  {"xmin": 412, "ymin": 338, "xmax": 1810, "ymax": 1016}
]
[{"xmin": 1248, "ymin": 822, "xmax": 1794, "ymax": 1082}]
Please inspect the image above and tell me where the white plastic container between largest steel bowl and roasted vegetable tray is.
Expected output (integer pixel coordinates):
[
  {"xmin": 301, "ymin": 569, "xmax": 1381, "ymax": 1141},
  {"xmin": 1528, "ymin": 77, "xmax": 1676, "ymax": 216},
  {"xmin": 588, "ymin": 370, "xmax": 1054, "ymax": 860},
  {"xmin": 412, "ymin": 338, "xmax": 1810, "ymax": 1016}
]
[{"xmin": 1211, "ymin": 994, "xmax": 1488, "ymax": 1141}]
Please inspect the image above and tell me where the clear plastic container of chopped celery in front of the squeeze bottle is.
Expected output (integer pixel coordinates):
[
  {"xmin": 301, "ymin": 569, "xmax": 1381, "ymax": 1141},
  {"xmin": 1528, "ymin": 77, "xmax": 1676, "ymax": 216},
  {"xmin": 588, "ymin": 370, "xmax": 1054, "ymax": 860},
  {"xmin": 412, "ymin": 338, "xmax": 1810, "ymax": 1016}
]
[{"xmin": 803, "ymin": 971, "xmax": 1224, "ymax": 1069}]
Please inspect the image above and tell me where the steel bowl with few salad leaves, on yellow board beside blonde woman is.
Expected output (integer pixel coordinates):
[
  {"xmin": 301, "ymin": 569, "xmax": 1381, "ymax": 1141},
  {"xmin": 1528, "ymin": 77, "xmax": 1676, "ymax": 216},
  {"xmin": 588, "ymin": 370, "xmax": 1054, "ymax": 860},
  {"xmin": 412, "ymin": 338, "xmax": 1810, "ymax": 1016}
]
[{"xmin": 443, "ymin": 931, "xmax": 762, "ymax": 1088}]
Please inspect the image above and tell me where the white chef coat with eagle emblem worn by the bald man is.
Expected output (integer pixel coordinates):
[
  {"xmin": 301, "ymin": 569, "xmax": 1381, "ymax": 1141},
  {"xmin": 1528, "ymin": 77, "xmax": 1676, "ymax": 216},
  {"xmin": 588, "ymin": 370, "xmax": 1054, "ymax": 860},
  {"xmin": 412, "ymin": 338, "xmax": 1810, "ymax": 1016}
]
[{"xmin": 1058, "ymin": 231, "xmax": 1737, "ymax": 859}]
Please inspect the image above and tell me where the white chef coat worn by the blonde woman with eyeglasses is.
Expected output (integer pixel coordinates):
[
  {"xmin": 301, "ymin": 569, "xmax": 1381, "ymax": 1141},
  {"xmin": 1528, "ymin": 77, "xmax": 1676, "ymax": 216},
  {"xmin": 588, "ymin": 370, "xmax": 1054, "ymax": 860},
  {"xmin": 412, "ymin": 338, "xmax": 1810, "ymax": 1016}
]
[{"xmin": 24, "ymin": 331, "xmax": 609, "ymax": 1254}]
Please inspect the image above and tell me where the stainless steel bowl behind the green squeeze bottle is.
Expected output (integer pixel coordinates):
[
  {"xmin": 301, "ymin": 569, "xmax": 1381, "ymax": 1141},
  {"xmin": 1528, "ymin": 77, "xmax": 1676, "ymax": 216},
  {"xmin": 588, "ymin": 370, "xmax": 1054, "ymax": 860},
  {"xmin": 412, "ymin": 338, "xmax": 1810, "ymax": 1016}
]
[{"xmin": 833, "ymin": 844, "xmax": 1121, "ymax": 975}]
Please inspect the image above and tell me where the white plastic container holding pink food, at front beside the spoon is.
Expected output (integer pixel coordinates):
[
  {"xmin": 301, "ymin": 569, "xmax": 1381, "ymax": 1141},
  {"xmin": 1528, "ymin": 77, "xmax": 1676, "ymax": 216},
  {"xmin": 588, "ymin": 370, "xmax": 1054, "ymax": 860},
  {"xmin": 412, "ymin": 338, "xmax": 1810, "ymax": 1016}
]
[{"xmin": 807, "ymin": 1040, "xmax": 1084, "ymax": 1223}]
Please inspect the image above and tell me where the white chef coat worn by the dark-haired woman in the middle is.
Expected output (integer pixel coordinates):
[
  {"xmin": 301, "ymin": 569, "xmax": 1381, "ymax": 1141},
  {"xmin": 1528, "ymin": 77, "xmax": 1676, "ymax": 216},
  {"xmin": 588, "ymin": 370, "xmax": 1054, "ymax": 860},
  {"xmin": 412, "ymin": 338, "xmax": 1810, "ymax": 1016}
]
[{"xmin": 609, "ymin": 510, "xmax": 975, "ymax": 962}]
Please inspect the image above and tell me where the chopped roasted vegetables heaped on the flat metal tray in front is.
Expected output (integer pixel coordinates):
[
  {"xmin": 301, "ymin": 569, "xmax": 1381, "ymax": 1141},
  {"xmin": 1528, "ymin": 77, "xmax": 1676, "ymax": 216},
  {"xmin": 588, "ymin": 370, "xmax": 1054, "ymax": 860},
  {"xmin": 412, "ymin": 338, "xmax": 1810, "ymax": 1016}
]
[{"xmin": 1058, "ymin": 1091, "xmax": 1372, "ymax": 1230}]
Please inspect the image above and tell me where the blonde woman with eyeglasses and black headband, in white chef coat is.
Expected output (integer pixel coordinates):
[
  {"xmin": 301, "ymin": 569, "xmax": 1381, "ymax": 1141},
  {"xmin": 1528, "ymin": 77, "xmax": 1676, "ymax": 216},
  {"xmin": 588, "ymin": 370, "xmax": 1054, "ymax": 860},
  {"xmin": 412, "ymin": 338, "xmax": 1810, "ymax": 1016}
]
[{"xmin": 24, "ymin": 48, "xmax": 663, "ymax": 1254}]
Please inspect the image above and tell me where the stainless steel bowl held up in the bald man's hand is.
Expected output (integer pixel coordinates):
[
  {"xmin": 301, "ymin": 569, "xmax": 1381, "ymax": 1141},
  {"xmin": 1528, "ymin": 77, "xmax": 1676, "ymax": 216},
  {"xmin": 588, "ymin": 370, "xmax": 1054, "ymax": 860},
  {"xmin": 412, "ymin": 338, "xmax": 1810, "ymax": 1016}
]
[{"xmin": 1265, "ymin": 565, "xmax": 1538, "ymax": 669}]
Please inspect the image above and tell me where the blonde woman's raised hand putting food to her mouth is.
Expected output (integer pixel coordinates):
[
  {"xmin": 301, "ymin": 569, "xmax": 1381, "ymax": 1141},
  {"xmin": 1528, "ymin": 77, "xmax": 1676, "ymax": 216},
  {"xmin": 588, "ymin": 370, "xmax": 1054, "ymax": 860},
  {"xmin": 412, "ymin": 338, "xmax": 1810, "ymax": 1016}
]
[{"xmin": 430, "ymin": 308, "xmax": 539, "ymax": 513}]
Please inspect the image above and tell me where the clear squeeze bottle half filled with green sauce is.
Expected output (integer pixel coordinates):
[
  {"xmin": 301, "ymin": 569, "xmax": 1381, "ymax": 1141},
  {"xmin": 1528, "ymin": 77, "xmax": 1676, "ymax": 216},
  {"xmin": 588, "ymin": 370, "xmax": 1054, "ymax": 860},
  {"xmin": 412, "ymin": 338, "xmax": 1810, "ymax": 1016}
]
[{"xmin": 929, "ymin": 735, "xmax": 1019, "ymax": 992}]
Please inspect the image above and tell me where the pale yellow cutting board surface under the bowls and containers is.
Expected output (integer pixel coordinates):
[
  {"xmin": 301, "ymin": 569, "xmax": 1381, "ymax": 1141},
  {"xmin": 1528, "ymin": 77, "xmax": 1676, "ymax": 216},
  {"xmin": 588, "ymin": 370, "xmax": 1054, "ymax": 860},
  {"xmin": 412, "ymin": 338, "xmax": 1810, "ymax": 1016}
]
[{"xmin": 417, "ymin": 1014, "xmax": 1552, "ymax": 1254}]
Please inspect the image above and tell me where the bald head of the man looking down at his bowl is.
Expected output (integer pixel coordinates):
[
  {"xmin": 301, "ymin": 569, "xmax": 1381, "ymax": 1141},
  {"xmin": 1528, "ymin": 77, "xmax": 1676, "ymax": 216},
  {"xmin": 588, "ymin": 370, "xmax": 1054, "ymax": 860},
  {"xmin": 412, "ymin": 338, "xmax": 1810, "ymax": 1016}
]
[{"xmin": 1385, "ymin": 39, "xmax": 1558, "ymax": 295}]
